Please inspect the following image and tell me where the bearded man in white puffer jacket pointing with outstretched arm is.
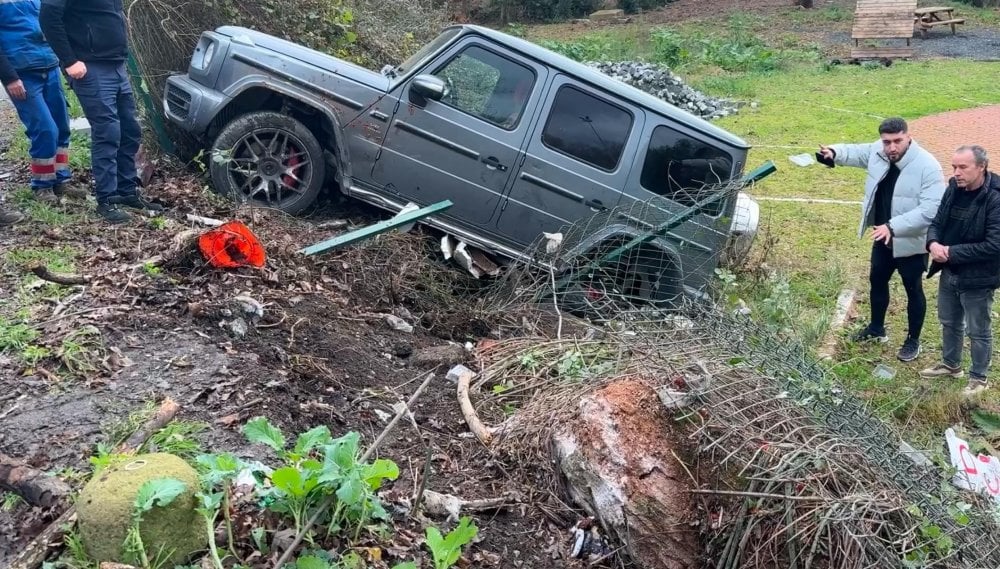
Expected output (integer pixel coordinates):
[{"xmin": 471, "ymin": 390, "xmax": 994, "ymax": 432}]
[{"xmin": 819, "ymin": 118, "xmax": 945, "ymax": 362}]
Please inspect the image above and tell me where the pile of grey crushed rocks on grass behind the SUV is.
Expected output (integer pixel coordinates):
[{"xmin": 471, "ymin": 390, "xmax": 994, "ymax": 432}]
[{"xmin": 589, "ymin": 61, "xmax": 737, "ymax": 120}]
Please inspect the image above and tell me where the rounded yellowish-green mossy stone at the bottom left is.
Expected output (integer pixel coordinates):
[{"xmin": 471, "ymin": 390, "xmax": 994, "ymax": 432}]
[{"xmin": 76, "ymin": 453, "xmax": 208, "ymax": 567}]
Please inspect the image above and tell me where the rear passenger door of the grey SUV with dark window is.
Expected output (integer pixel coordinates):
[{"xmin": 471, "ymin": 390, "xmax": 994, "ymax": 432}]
[{"xmin": 497, "ymin": 75, "xmax": 644, "ymax": 245}]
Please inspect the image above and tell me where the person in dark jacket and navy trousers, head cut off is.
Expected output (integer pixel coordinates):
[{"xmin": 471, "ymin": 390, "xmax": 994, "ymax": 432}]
[{"xmin": 41, "ymin": 0, "xmax": 163, "ymax": 223}]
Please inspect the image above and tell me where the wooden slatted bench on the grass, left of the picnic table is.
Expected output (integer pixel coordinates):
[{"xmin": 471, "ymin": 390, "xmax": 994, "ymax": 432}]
[{"xmin": 851, "ymin": 0, "xmax": 917, "ymax": 59}]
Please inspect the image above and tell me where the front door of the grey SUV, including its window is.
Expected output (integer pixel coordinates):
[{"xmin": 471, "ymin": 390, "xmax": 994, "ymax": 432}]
[{"xmin": 372, "ymin": 38, "xmax": 546, "ymax": 229}]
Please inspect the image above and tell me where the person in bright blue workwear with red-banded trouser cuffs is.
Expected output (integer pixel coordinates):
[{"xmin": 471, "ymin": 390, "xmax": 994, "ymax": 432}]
[{"xmin": 0, "ymin": 0, "xmax": 86, "ymax": 220}]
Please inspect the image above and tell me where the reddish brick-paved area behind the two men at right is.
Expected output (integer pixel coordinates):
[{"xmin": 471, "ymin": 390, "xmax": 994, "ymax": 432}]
[{"xmin": 910, "ymin": 105, "xmax": 1000, "ymax": 171}]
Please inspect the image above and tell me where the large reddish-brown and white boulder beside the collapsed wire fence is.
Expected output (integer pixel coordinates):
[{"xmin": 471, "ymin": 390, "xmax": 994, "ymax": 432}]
[{"xmin": 553, "ymin": 380, "xmax": 701, "ymax": 569}]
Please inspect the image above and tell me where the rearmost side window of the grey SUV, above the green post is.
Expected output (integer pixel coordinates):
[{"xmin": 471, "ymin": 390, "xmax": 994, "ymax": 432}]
[{"xmin": 639, "ymin": 126, "xmax": 733, "ymax": 215}]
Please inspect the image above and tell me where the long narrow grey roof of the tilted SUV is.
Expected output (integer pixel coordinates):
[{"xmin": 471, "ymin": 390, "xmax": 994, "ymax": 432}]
[{"xmin": 445, "ymin": 25, "xmax": 750, "ymax": 149}]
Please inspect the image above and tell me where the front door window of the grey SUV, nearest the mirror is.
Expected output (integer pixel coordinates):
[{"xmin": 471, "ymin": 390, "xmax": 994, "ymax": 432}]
[{"xmin": 434, "ymin": 46, "xmax": 535, "ymax": 130}]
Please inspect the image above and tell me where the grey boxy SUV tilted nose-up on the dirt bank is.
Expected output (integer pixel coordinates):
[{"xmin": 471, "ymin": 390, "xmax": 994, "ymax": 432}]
[{"xmin": 164, "ymin": 26, "xmax": 757, "ymax": 300}]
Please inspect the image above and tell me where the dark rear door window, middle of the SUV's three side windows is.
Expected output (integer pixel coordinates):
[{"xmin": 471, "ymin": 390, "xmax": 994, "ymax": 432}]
[{"xmin": 542, "ymin": 85, "xmax": 633, "ymax": 172}]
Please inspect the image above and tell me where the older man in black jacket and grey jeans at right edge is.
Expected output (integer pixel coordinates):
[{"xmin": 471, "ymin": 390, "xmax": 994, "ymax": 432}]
[{"xmin": 920, "ymin": 146, "xmax": 1000, "ymax": 395}]
